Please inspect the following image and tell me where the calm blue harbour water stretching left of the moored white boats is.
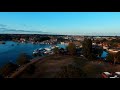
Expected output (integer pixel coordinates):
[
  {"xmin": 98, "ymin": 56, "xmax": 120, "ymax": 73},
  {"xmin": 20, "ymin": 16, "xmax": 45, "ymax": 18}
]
[{"xmin": 0, "ymin": 41, "xmax": 65, "ymax": 67}]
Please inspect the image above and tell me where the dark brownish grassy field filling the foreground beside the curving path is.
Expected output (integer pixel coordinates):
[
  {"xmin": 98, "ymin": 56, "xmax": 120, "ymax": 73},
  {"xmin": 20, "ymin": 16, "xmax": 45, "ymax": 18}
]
[{"xmin": 19, "ymin": 55, "xmax": 120, "ymax": 78}]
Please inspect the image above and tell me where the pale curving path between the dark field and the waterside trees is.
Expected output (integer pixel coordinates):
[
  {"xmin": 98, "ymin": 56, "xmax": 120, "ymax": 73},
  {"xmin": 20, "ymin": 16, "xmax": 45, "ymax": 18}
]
[{"xmin": 6, "ymin": 54, "xmax": 50, "ymax": 78}]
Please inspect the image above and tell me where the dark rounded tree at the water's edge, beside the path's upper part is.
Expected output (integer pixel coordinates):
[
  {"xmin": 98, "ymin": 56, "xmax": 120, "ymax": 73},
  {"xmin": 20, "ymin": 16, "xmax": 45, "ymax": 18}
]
[{"xmin": 17, "ymin": 53, "xmax": 30, "ymax": 65}]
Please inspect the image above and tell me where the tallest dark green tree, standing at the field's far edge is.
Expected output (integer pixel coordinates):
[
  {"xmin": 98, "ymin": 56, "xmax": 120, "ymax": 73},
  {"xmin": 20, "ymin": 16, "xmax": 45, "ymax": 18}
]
[{"xmin": 82, "ymin": 38, "xmax": 92, "ymax": 59}]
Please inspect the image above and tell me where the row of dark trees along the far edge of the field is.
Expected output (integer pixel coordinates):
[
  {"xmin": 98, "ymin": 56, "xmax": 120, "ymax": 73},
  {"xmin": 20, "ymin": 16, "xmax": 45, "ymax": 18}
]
[{"xmin": 54, "ymin": 38, "xmax": 103, "ymax": 60}]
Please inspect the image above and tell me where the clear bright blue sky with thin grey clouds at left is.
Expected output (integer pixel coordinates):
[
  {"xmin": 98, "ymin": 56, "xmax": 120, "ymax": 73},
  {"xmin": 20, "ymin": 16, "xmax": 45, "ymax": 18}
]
[{"xmin": 0, "ymin": 12, "xmax": 120, "ymax": 35}]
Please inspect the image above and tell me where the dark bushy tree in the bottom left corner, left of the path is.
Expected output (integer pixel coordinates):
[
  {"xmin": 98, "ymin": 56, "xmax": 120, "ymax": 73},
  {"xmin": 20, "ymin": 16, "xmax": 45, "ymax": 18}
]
[{"xmin": 0, "ymin": 62, "xmax": 18, "ymax": 77}]
